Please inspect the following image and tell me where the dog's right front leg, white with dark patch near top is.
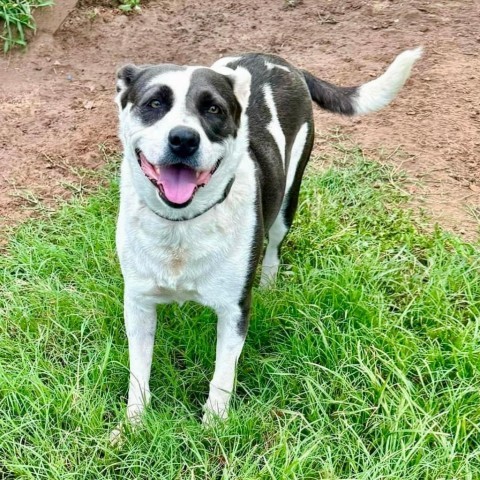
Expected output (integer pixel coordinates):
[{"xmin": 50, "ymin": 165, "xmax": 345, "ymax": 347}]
[{"xmin": 203, "ymin": 305, "xmax": 250, "ymax": 424}]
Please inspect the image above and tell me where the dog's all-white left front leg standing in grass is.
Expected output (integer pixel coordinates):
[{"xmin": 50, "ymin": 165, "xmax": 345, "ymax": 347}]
[{"xmin": 124, "ymin": 289, "xmax": 157, "ymax": 424}]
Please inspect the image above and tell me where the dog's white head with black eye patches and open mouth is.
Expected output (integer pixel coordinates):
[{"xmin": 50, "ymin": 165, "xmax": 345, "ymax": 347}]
[{"xmin": 116, "ymin": 65, "xmax": 250, "ymax": 220}]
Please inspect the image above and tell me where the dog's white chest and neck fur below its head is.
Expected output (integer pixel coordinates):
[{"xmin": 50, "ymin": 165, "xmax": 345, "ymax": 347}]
[{"xmin": 117, "ymin": 156, "xmax": 256, "ymax": 306}]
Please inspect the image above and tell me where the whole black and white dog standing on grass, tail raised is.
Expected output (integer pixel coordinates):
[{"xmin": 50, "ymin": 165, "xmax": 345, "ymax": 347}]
[{"xmin": 112, "ymin": 49, "xmax": 421, "ymax": 421}]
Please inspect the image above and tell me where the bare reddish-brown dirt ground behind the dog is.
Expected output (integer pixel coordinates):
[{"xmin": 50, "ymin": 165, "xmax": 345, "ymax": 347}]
[{"xmin": 0, "ymin": 0, "xmax": 480, "ymax": 239}]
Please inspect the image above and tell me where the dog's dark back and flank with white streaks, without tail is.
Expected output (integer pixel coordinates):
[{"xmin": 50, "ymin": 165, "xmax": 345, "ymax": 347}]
[{"xmin": 213, "ymin": 53, "xmax": 314, "ymax": 231}]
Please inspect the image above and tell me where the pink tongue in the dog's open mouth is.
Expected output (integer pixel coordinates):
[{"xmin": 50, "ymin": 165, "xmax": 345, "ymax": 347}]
[{"xmin": 159, "ymin": 165, "xmax": 197, "ymax": 205}]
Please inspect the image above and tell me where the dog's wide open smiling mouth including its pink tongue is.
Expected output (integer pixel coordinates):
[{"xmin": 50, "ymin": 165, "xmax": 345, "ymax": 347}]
[{"xmin": 136, "ymin": 149, "xmax": 221, "ymax": 208}]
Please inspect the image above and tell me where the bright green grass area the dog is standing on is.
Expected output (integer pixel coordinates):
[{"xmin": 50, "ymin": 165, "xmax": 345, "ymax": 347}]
[{"xmin": 0, "ymin": 144, "xmax": 480, "ymax": 480}]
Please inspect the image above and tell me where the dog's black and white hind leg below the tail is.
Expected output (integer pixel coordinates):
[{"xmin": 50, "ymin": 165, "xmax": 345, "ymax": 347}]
[{"xmin": 260, "ymin": 122, "xmax": 314, "ymax": 287}]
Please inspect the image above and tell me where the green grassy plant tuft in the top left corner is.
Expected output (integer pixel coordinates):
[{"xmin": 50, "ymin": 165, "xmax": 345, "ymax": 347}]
[{"xmin": 0, "ymin": 0, "xmax": 53, "ymax": 53}]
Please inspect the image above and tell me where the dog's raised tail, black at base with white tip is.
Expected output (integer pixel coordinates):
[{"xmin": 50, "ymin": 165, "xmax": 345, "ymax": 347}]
[{"xmin": 302, "ymin": 47, "xmax": 422, "ymax": 115}]
